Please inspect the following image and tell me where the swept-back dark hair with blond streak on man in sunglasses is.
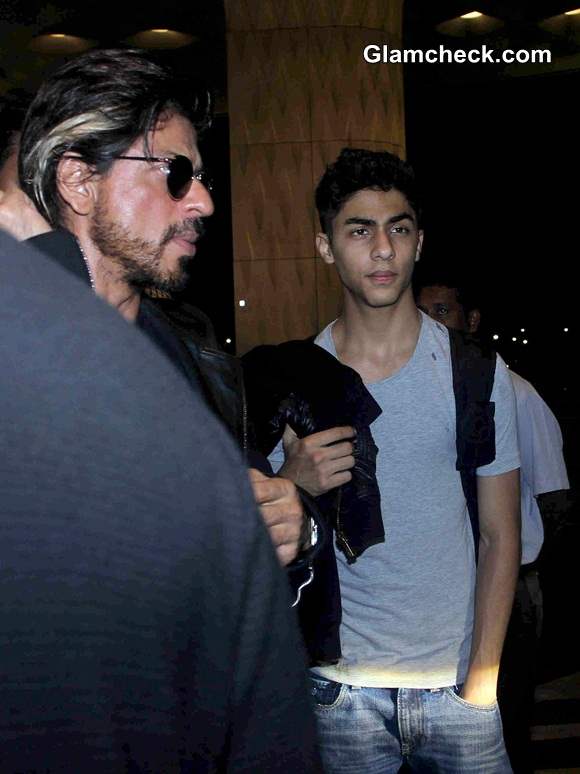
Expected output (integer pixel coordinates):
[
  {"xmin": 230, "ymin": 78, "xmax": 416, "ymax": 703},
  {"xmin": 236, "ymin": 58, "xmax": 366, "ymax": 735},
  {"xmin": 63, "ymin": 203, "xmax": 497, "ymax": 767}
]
[{"xmin": 19, "ymin": 49, "xmax": 210, "ymax": 226}]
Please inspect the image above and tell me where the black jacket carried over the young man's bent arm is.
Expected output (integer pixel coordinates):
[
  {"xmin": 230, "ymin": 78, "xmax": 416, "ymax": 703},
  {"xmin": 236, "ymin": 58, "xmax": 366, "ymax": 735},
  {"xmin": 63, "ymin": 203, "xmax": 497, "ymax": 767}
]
[{"xmin": 242, "ymin": 338, "xmax": 385, "ymax": 664}]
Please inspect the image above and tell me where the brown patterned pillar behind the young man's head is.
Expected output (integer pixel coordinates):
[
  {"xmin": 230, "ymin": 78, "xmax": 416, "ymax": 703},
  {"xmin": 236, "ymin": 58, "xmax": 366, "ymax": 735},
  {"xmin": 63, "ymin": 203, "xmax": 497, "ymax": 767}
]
[{"xmin": 225, "ymin": 0, "xmax": 404, "ymax": 354}]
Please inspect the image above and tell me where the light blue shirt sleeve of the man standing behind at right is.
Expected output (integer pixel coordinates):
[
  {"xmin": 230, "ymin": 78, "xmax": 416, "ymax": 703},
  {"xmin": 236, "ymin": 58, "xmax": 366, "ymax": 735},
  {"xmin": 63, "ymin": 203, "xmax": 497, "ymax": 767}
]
[{"xmin": 516, "ymin": 387, "xmax": 570, "ymax": 496}]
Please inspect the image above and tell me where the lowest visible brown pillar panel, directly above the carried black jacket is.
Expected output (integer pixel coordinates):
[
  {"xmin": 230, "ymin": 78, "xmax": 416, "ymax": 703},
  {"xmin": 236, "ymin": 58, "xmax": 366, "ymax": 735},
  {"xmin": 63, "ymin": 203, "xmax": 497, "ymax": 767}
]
[{"xmin": 234, "ymin": 258, "xmax": 318, "ymax": 354}]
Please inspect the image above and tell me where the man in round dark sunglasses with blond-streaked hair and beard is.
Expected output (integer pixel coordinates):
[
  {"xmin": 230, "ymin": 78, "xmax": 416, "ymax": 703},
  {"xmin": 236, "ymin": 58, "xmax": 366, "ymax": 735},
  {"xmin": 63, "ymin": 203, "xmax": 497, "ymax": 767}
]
[{"xmin": 19, "ymin": 50, "xmax": 307, "ymax": 564}]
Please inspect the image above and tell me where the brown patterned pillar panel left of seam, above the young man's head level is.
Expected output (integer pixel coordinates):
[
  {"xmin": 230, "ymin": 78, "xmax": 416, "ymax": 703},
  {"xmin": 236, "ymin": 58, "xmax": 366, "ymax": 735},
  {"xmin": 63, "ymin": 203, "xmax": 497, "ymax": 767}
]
[{"xmin": 228, "ymin": 30, "xmax": 310, "ymax": 145}]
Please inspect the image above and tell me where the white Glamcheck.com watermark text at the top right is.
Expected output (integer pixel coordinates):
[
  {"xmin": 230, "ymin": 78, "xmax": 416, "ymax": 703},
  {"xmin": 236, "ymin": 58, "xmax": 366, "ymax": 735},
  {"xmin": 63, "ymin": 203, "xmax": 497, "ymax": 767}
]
[{"xmin": 363, "ymin": 44, "xmax": 552, "ymax": 64}]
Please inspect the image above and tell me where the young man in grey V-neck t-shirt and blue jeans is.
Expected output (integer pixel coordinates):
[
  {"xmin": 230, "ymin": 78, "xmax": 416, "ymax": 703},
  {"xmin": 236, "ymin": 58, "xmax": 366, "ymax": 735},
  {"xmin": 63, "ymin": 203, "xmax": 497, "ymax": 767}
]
[{"xmin": 266, "ymin": 149, "xmax": 519, "ymax": 774}]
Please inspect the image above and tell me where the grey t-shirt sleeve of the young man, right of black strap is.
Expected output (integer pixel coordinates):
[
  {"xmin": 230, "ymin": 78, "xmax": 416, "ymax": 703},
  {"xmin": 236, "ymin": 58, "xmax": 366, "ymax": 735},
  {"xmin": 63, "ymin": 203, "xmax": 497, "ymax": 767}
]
[{"xmin": 477, "ymin": 355, "xmax": 520, "ymax": 476}]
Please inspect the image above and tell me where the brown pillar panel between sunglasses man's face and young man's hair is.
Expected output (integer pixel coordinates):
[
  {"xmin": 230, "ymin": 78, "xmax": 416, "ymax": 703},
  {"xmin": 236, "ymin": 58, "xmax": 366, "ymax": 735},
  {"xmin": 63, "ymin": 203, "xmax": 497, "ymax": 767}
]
[{"xmin": 231, "ymin": 143, "xmax": 314, "ymax": 261}]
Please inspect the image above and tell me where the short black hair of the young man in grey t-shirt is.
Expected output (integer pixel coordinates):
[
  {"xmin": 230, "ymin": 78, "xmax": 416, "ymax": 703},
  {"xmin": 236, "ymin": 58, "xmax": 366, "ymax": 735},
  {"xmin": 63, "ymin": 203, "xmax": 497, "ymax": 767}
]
[{"xmin": 316, "ymin": 148, "xmax": 422, "ymax": 237}]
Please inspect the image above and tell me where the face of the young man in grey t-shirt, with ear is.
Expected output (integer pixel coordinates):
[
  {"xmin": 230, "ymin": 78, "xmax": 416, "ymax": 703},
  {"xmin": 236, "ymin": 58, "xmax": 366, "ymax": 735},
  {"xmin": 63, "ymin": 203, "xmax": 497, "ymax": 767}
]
[{"xmin": 317, "ymin": 188, "xmax": 423, "ymax": 308}]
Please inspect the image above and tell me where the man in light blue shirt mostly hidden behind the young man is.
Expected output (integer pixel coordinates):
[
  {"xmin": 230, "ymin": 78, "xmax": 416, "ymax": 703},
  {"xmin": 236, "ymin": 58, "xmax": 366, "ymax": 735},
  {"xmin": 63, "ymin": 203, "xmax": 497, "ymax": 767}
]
[{"xmin": 417, "ymin": 271, "xmax": 570, "ymax": 774}]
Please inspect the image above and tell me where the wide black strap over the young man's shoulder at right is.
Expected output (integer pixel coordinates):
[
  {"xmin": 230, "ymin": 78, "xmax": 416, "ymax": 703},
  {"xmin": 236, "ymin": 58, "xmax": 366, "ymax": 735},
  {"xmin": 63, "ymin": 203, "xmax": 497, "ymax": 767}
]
[{"xmin": 449, "ymin": 329, "xmax": 496, "ymax": 559}]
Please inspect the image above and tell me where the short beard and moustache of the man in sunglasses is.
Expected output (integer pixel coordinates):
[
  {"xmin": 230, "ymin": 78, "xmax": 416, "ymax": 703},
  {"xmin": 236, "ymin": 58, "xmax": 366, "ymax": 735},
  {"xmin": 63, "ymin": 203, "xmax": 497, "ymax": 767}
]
[{"xmin": 89, "ymin": 200, "xmax": 204, "ymax": 293}]
